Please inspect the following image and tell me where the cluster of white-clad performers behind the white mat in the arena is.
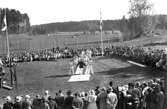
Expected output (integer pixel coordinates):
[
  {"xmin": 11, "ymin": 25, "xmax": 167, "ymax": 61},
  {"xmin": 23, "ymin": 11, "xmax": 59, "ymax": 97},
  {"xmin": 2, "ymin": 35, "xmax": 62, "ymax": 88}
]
[{"xmin": 69, "ymin": 50, "xmax": 94, "ymax": 75}]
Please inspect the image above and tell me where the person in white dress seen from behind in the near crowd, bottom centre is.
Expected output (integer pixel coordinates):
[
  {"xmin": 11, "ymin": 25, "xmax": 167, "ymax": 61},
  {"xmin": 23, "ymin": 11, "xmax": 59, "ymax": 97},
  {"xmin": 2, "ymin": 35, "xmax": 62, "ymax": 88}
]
[{"xmin": 87, "ymin": 90, "xmax": 97, "ymax": 109}]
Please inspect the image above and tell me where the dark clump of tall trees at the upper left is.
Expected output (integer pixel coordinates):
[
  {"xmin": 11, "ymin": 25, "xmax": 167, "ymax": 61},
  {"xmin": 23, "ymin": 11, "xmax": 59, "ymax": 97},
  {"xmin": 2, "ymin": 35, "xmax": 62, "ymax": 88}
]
[{"xmin": 0, "ymin": 8, "xmax": 31, "ymax": 34}]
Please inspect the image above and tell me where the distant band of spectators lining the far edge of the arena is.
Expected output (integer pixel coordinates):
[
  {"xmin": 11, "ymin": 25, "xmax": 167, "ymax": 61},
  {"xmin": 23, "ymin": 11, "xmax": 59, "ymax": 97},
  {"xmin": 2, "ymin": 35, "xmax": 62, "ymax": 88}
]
[{"xmin": 0, "ymin": 46, "xmax": 167, "ymax": 69}]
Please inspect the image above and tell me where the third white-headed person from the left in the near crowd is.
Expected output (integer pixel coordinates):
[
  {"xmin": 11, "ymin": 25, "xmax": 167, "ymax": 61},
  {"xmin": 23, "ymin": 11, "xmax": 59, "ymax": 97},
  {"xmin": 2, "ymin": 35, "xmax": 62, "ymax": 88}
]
[{"xmin": 22, "ymin": 95, "xmax": 32, "ymax": 109}]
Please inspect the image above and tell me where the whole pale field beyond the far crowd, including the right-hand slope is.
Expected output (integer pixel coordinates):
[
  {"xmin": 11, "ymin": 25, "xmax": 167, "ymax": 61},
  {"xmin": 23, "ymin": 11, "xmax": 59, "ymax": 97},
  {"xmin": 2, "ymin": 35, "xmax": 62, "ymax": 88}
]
[{"xmin": 0, "ymin": 30, "xmax": 167, "ymax": 54}]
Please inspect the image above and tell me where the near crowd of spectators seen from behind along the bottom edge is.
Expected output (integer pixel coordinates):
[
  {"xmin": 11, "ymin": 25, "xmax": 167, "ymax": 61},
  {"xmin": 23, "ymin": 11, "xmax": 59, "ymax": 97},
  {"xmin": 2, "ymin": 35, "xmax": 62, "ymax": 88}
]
[{"xmin": 2, "ymin": 79, "xmax": 165, "ymax": 109}]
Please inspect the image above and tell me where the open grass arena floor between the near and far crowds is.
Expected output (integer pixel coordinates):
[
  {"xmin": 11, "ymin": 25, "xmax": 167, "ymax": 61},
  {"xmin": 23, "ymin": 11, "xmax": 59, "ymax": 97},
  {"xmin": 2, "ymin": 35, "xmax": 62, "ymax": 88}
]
[{"xmin": 0, "ymin": 57, "xmax": 162, "ymax": 101}]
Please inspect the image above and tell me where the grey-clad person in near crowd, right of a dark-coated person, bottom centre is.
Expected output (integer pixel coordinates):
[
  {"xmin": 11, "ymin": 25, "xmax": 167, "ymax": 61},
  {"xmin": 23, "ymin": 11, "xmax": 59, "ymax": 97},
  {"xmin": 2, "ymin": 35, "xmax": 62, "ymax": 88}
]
[{"xmin": 72, "ymin": 92, "xmax": 83, "ymax": 109}]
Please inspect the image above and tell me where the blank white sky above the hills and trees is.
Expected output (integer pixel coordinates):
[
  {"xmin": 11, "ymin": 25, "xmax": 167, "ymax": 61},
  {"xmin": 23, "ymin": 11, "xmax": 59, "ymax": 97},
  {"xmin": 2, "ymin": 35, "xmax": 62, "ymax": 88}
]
[{"xmin": 0, "ymin": 0, "xmax": 167, "ymax": 25}]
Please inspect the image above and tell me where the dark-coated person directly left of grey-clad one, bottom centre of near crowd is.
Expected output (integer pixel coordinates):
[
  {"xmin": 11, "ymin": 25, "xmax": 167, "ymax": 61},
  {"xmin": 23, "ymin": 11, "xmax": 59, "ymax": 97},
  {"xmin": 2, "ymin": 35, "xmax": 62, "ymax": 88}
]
[{"xmin": 63, "ymin": 90, "xmax": 73, "ymax": 109}]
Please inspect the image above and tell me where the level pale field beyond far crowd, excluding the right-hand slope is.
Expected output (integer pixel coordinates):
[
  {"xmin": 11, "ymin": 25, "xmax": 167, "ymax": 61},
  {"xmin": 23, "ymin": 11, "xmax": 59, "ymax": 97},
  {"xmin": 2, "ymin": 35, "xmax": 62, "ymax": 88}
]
[{"xmin": 0, "ymin": 32, "xmax": 119, "ymax": 54}]
